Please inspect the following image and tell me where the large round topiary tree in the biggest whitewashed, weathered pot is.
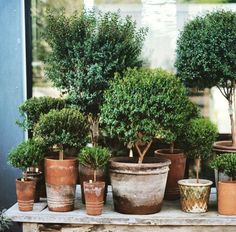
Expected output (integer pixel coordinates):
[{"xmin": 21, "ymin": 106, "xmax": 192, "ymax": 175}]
[{"xmin": 101, "ymin": 69, "xmax": 194, "ymax": 214}]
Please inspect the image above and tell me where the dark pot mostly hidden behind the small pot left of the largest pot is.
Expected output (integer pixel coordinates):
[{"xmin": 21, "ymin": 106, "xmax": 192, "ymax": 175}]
[{"xmin": 79, "ymin": 165, "xmax": 107, "ymax": 204}]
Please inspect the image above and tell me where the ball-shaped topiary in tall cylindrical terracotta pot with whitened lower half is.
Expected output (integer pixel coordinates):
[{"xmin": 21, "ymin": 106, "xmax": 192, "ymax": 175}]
[{"xmin": 34, "ymin": 108, "xmax": 88, "ymax": 212}]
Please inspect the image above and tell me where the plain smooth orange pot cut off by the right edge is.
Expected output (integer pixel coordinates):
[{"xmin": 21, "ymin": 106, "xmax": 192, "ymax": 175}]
[{"xmin": 218, "ymin": 181, "xmax": 236, "ymax": 215}]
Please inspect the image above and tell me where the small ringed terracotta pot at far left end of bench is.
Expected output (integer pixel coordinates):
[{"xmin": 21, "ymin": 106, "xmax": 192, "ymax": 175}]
[{"xmin": 16, "ymin": 179, "xmax": 36, "ymax": 211}]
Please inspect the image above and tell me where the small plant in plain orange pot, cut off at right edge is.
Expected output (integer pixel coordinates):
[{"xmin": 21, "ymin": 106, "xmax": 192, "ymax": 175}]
[{"xmin": 210, "ymin": 153, "xmax": 236, "ymax": 215}]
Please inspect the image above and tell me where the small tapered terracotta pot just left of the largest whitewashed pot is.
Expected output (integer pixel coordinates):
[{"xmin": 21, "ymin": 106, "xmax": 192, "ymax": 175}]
[{"xmin": 83, "ymin": 181, "xmax": 105, "ymax": 216}]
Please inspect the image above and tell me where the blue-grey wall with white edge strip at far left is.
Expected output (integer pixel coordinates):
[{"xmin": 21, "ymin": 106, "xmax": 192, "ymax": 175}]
[{"xmin": 0, "ymin": 0, "xmax": 28, "ymax": 211}]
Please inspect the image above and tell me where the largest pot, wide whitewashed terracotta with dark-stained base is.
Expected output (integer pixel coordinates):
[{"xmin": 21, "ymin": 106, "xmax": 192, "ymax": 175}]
[{"xmin": 110, "ymin": 157, "xmax": 170, "ymax": 214}]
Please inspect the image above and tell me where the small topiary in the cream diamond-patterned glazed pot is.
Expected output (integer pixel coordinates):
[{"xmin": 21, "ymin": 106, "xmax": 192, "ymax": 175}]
[{"xmin": 178, "ymin": 118, "xmax": 217, "ymax": 213}]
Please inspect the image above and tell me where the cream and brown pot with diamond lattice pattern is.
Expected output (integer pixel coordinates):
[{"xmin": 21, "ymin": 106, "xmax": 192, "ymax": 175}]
[{"xmin": 178, "ymin": 179, "xmax": 212, "ymax": 213}]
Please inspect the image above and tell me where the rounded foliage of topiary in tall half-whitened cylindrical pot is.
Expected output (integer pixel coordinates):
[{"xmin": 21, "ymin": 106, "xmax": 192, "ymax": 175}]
[{"xmin": 34, "ymin": 108, "xmax": 89, "ymax": 149}]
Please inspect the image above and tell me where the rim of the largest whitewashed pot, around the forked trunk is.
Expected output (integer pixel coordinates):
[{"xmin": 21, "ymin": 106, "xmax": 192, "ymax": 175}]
[{"xmin": 109, "ymin": 157, "xmax": 171, "ymax": 168}]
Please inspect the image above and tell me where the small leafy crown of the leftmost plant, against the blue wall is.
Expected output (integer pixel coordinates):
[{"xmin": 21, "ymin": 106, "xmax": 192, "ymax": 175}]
[{"xmin": 7, "ymin": 139, "xmax": 44, "ymax": 171}]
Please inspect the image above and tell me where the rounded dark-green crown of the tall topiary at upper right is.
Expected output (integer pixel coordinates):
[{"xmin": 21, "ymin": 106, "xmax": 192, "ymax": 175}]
[{"xmin": 175, "ymin": 10, "xmax": 236, "ymax": 88}]
